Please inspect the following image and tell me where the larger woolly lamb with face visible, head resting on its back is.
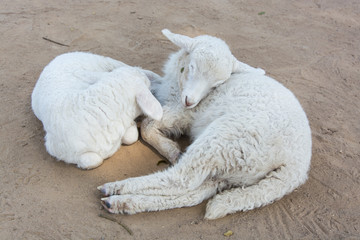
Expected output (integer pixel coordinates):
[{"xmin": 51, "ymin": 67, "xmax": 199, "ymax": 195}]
[{"xmin": 98, "ymin": 30, "xmax": 311, "ymax": 219}]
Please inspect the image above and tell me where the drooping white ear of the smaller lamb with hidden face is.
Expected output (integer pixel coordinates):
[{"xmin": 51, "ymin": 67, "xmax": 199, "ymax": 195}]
[{"xmin": 136, "ymin": 87, "xmax": 163, "ymax": 121}]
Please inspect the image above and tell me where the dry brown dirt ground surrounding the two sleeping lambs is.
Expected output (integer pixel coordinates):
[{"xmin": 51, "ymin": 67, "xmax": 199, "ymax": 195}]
[{"xmin": 0, "ymin": 0, "xmax": 360, "ymax": 239}]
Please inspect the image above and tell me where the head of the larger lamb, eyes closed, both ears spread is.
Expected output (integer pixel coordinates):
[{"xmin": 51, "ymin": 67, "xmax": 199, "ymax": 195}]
[{"xmin": 162, "ymin": 29, "xmax": 262, "ymax": 108}]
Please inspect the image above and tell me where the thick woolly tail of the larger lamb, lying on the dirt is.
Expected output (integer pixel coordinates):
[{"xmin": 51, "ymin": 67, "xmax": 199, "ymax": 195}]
[{"xmin": 205, "ymin": 166, "xmax": 307, "ymax": 219}]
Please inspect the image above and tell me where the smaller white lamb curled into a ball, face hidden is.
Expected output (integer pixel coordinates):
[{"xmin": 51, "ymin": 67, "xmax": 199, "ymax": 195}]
[{"xmin": 32, "ymin": 52, "xmax": 162, "ymax": 169}]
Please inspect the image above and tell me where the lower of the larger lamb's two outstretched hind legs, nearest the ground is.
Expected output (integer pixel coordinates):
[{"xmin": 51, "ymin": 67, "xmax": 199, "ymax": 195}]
[{"xmin": 102, "ymin": 180, "xmax": 218, "ymax": 214}]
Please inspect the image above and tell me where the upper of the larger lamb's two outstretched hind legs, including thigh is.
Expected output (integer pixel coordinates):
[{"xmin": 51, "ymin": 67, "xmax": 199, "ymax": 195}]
[{"xmin": 98, "ymin": 126, "xmax": 224, "ymax": 196}]
